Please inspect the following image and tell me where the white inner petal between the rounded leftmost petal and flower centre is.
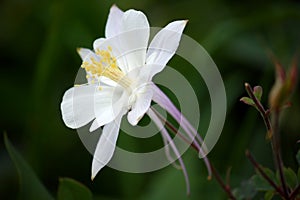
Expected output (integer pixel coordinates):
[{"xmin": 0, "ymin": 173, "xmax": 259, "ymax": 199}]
[{"xmin": 90, "ymin": 87, "xmax": 128, "ymax": 132}]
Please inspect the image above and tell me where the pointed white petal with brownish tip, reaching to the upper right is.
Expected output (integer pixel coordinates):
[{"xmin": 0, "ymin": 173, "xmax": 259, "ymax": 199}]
[{"xmin": 146, "ymin": 20, "xmax": 187, "ymax": 76}]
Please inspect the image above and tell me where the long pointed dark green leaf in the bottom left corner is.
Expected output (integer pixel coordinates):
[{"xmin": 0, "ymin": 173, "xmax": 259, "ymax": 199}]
[{"xmin": 4, "ymin": 134, "xmax": 53, "ymax": 200}]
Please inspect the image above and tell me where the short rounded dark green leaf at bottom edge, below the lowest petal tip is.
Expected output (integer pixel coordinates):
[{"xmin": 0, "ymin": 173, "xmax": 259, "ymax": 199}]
[{"xmin": 57, "ymin": 178, "xmax": 93, "ymax": 200}]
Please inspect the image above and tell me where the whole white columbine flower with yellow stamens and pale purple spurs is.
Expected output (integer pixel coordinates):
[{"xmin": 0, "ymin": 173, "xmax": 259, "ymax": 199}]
[{"xmin": 61, "ymin": 6, "xmax": 209, "ymax": 194}]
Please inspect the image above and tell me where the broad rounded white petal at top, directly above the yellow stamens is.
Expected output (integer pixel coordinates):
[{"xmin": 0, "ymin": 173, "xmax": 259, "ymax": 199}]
[{"xmin": 118, "ymin": 10, "xmax": 150, "ymax": 72}]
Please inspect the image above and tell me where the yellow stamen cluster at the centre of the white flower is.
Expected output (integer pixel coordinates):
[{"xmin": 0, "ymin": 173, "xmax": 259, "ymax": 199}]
[{"xmin": 81, "ymin": 46, "xmax": 132, "ymax": 88}]
